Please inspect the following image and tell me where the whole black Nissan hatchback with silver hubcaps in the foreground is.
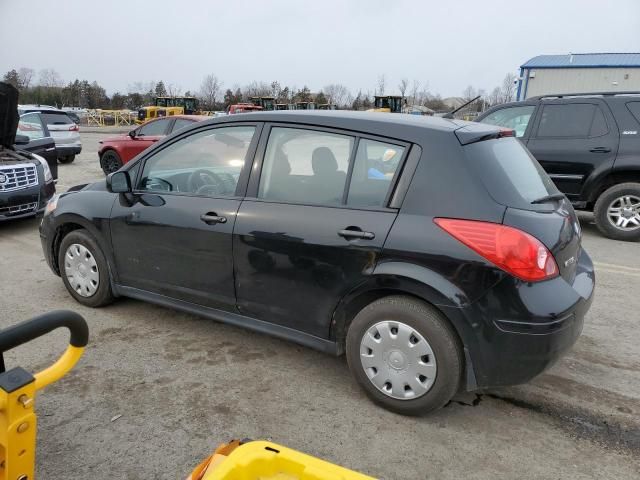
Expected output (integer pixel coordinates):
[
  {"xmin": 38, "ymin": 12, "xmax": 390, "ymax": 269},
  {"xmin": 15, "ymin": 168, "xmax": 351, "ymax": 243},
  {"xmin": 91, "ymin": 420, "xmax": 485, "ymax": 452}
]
[{"xmin": 41, "ymin": 112, "xmax": 594, "ymax": 414}]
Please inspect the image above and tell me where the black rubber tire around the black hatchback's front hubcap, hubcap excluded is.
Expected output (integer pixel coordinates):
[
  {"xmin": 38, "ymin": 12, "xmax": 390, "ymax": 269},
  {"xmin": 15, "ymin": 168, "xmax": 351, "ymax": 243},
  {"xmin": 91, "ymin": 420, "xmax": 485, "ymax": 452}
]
[{"xmin": 58, "ymin": 229, "xmax": 114, "ymax": 307}]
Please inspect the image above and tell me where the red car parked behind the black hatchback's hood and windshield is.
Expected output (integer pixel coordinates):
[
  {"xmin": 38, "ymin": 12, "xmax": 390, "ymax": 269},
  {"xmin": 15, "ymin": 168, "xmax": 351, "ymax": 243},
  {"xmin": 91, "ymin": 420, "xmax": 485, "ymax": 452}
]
[{"xmin": 98, "ymin": 115, "xmax": 211, "ymax": 175}]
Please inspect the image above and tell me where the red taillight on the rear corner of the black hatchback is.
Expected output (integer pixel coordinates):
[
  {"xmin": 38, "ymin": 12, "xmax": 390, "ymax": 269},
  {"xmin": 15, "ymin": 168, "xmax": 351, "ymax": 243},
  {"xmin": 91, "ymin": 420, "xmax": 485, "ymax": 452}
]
[{"xmin": 434, "ymin": 218, "xmax": 558, "ymax": 282}]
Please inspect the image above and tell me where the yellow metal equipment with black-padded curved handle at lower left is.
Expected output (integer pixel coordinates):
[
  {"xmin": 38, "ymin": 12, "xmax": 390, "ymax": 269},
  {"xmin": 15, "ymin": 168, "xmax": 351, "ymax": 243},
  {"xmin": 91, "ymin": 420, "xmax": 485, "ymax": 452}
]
[{"xmin": 0, "ymin": 310, "xmax": 89, "ymax": 480}]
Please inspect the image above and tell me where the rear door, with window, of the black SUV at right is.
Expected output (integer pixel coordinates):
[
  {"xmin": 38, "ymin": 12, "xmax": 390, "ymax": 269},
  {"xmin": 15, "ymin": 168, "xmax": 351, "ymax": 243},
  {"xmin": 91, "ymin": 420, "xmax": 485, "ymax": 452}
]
[{"xmin": 527, "ymin": 98, "xmax": 618, "ymax": 201}]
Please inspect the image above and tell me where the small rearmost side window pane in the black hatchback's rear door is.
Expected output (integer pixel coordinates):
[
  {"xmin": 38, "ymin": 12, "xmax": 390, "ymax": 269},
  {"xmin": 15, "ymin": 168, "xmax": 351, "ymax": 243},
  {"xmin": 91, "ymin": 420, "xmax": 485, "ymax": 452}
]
[{"xmin": 347, "ymin": 139, "xmax": 405, "ymax": 207}]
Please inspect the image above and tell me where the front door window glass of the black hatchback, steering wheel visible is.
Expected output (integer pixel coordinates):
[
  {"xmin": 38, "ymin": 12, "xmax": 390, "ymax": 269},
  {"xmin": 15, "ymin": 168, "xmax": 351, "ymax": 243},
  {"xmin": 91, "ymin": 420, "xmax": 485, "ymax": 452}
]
[{"xmin": 139, "ymin": 126, "xmax": 255, "ymax": 197}]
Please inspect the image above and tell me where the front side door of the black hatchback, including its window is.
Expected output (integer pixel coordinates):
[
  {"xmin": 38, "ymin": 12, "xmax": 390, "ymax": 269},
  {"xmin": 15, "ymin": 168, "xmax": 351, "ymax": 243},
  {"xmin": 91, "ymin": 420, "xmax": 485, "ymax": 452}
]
[{"xmin": 111, "ymin": 125, "xmax": 256, "ymax": 310}]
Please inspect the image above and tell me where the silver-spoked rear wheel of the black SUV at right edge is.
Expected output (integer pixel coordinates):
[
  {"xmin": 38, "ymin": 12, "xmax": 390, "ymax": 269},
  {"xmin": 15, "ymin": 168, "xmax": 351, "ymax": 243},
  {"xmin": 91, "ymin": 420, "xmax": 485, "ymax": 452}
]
[{"xmin": 593, "ymin": 183, "xmax": 640, "ymax": 241}]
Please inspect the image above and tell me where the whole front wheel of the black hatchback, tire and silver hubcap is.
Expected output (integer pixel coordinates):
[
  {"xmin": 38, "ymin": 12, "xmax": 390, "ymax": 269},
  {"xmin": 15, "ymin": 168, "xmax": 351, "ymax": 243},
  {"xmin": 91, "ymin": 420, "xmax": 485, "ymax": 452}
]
[{"xmin": 58, "ymin": 229, "xmax": 114, "ymax": 307}]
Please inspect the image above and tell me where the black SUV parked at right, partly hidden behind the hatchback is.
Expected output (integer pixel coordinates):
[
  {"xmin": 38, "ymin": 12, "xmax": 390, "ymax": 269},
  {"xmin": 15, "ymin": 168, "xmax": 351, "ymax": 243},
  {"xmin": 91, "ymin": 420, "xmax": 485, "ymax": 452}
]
[{"xmin": 477, "ymin": 93, "xmax": 640, "ymax": 240}]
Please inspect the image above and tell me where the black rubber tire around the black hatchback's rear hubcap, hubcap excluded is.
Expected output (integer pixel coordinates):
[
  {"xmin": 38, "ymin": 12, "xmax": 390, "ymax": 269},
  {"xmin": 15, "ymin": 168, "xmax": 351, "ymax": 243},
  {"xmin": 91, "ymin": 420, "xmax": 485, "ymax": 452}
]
[{"xmin": 346, "ymin": 296, "xmax": 464, "ymax": 415}]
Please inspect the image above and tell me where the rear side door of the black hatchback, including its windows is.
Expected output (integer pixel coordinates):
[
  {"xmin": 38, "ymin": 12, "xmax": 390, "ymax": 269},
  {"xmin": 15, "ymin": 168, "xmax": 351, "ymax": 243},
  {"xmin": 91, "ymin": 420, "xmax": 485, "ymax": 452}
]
[{"xmin": 233, "ymin": 125, "xmax": 408, "ymax": 338}]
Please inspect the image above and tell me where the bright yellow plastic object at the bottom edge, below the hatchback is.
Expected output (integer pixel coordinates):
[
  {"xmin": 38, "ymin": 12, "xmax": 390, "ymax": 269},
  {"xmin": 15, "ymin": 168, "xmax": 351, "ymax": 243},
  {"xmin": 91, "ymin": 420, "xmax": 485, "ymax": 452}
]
[{"xmin": 200, "ymin": 441, "xmax": 373, "ymax": 480}]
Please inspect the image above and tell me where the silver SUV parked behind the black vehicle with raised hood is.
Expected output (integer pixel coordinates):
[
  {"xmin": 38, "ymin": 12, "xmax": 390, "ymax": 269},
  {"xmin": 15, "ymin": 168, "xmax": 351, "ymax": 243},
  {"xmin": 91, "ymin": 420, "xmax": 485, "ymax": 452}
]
[{"xmin": 18, "ymin": 105, "xmax": 82, "ymax": 163}]
